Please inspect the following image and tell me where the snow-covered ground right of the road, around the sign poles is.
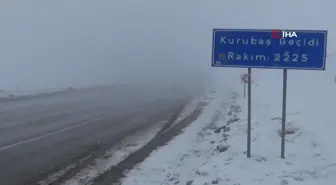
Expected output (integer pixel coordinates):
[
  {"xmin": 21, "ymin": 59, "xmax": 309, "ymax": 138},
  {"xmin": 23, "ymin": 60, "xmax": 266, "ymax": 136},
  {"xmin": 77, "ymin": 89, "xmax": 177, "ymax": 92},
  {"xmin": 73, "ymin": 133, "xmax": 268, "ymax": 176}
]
[{"xmin": 122, "ymin": 70, "xmax": 336, "ymax": 185}]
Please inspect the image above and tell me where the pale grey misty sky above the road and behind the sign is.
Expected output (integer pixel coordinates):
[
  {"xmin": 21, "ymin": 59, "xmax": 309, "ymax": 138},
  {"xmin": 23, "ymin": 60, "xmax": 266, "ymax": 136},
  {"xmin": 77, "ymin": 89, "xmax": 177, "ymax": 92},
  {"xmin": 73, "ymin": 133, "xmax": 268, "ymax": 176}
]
[{"xmin": 0, "ymin": 0, "xmax": 336, "ymax": 89}]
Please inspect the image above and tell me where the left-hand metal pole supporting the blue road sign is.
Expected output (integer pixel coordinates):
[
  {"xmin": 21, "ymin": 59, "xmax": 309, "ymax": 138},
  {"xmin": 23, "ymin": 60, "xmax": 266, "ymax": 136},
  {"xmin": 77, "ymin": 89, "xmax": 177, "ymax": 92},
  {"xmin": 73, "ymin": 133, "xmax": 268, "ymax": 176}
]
[{"xmin": 247, "ymin": 68, "xmax": 252, "ymax": 157}]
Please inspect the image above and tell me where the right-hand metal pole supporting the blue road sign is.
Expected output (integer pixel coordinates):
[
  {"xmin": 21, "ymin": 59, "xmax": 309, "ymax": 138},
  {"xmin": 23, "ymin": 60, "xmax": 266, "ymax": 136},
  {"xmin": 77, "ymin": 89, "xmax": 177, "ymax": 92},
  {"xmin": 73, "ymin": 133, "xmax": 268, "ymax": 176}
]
[{"xmin": 281, "ymin": 69, "xmax": 287, "ymax": 159}]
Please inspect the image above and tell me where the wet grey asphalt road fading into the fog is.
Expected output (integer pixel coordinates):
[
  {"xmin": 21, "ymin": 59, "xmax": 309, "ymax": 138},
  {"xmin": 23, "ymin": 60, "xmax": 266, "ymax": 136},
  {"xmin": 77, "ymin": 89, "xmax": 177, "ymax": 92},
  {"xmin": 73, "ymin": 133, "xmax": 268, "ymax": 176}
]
[{"xmin": 0, "ymin": 87, "xmax": 192, "ymax": 185}]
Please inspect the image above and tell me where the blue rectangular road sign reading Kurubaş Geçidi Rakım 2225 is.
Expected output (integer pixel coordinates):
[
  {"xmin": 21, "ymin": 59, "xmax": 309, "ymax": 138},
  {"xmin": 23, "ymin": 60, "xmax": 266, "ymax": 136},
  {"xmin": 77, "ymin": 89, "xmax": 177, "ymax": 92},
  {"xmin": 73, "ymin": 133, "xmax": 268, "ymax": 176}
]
[{"xmin": 212, "ymin": 29, "xmax": 327, "ymax": 70}]
